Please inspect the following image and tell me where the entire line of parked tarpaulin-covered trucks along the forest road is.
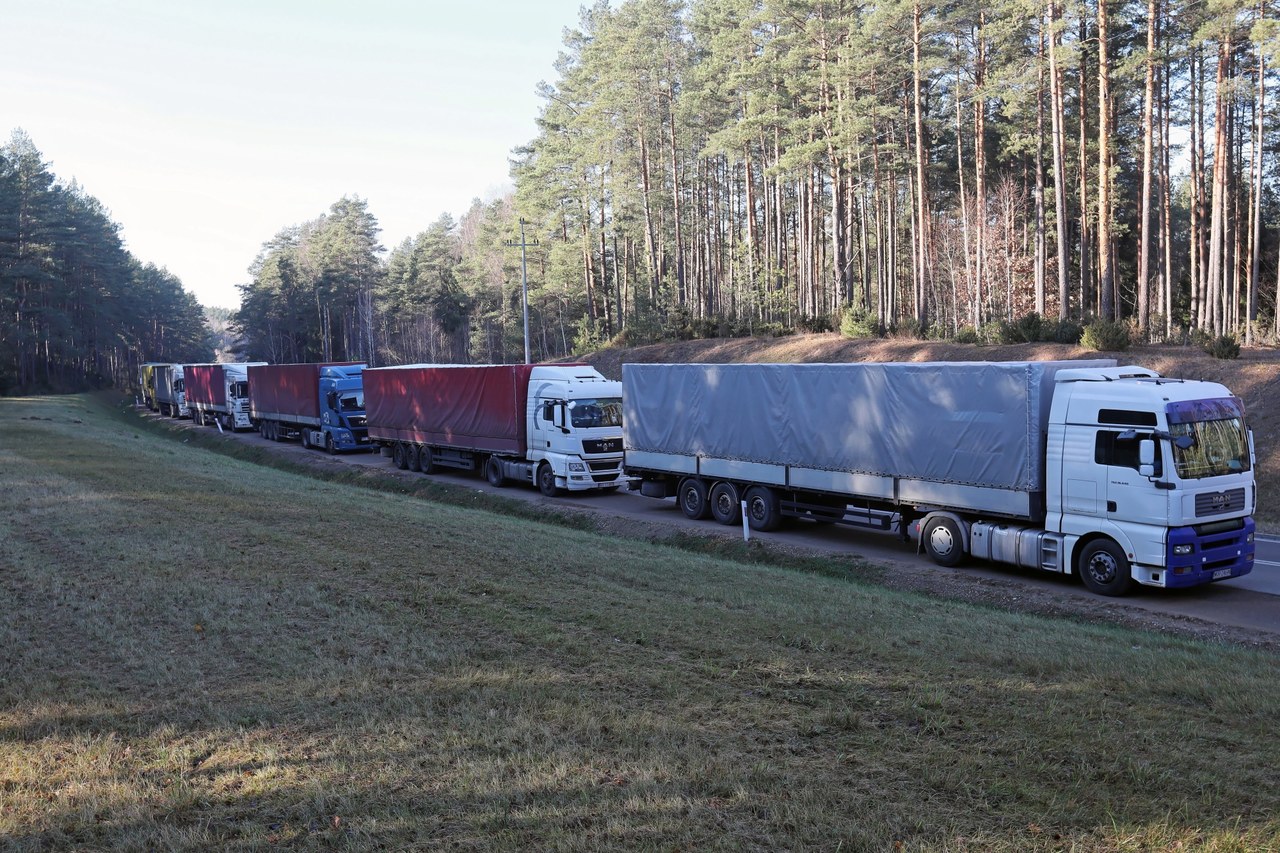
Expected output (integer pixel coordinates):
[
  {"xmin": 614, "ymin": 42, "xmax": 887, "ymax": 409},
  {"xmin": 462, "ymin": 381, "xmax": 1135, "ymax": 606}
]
[{"xmin": 140, "ymin": 360, "xmax": 1257, "ymax": 596}]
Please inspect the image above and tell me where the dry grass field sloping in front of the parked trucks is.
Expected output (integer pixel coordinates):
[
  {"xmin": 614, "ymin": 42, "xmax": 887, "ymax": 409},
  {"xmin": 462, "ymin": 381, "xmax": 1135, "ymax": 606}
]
[{"xmin": 0, "ymin": 397, "xmax": 1280, "ymax": 853}]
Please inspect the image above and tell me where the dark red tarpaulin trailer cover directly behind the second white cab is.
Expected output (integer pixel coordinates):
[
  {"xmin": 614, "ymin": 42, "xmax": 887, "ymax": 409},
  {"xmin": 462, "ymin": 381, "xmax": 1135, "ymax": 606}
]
[{"xmin": 365, "ymin": 364, "xmax": 534, "ymax": 455}]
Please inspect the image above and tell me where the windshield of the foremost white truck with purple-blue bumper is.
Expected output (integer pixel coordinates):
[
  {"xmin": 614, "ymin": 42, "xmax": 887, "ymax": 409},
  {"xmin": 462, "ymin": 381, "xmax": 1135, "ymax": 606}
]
[{"xmin": 1166, "ymin": 397, "xmax": 1249, "ymax": 480}]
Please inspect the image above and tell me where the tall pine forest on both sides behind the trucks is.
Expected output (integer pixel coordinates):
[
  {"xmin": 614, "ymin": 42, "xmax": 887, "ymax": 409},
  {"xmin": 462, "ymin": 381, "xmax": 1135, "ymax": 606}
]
[{"xmin": 0, "ymin": 0, "xmax": 1280, "ymax": 389}]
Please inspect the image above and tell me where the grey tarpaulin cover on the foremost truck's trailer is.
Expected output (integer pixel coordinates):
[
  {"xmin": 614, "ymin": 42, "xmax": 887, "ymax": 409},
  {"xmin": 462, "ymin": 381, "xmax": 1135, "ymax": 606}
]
[{"xmin": 622, "ymin": 360, "xmax": 1115, "ymax": 491}]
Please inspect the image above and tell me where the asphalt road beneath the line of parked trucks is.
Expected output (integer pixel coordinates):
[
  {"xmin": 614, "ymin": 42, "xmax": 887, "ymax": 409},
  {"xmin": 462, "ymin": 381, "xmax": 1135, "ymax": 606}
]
[{"xmin": 165, "ymin": 415, "xmax": 1280, "ymax": 635}]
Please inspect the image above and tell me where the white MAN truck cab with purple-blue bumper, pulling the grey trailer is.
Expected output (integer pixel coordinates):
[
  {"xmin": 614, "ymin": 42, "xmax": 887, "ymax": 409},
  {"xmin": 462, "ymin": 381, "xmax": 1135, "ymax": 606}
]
[{"xmin": 915, "ymin": 366, "xmax": 1257, "ymax": 596}]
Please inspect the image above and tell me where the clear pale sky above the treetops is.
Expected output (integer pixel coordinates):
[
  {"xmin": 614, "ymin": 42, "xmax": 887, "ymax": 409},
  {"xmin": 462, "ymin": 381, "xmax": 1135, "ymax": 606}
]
[{"xmin": 0, "ymin": 0, "xmax": 582, "ymax": 307}]
